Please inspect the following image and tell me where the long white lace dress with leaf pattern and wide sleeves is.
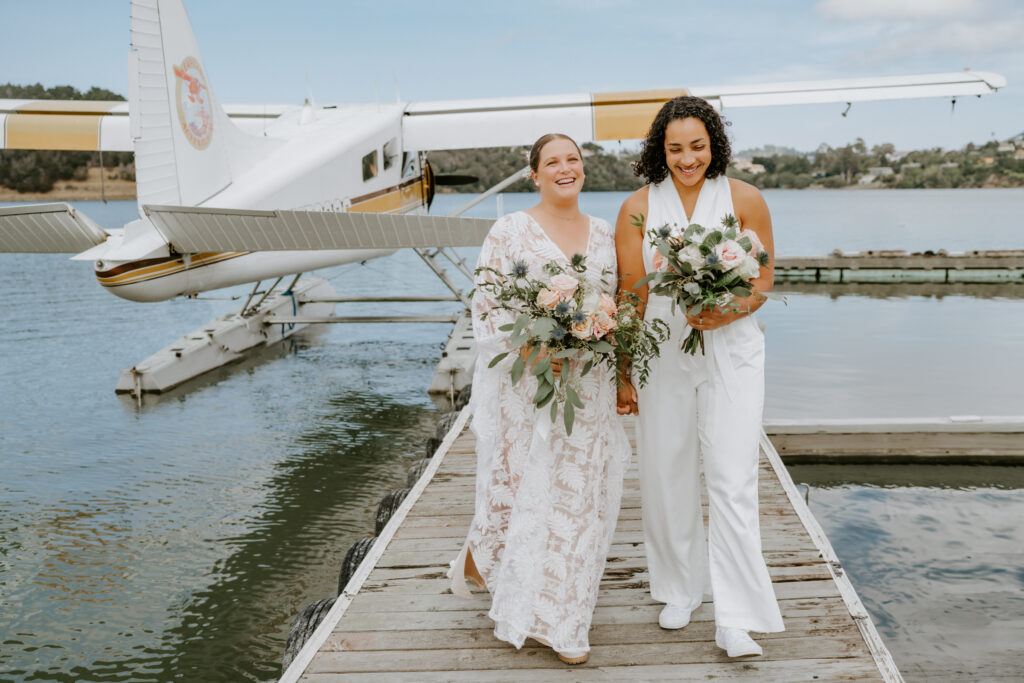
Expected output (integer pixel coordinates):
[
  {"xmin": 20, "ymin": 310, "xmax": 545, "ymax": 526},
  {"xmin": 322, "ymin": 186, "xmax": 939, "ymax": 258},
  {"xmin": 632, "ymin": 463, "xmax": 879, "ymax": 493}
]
[{"xmin": 453, "ymin": 212, "xmax": 632, "ymax": 651}]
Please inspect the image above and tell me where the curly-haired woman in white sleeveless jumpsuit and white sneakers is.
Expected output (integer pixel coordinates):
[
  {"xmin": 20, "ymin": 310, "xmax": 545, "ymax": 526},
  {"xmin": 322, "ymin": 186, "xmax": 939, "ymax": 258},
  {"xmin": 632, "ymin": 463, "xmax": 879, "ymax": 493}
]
[{"xmin": 615, "ymin": 97, "xmax": 784, "ymax": 656}]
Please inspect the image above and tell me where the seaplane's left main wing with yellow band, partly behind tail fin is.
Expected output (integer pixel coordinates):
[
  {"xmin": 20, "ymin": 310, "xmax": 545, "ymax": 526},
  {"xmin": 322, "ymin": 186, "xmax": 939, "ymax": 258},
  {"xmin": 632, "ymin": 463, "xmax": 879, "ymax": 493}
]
[{"xmin": 0, "ymin": 99, "xmax": 297, "ymax": 152}]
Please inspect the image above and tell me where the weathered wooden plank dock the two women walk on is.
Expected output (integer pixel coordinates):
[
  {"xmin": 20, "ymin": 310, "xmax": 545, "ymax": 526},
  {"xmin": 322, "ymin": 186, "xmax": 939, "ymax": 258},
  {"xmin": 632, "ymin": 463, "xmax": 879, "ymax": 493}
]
[{"xmin": 281, "ymin": 410, "xmax": 902, "ymax": 683}]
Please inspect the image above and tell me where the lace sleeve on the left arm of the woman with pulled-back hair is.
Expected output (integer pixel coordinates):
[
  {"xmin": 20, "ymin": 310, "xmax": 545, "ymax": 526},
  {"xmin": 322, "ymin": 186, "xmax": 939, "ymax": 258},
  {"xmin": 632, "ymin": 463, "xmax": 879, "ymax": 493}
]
[{"xmin": 472, "ymin": 220, "xmax": 515, "ymax": 365}]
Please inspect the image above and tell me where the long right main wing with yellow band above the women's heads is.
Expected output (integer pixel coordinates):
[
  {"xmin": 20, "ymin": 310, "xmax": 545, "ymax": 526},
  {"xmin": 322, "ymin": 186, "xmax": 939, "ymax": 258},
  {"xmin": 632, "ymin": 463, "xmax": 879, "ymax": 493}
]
[{"xmin": 402, "ymin": 71, "xmax": 1007, "ymax": 152}]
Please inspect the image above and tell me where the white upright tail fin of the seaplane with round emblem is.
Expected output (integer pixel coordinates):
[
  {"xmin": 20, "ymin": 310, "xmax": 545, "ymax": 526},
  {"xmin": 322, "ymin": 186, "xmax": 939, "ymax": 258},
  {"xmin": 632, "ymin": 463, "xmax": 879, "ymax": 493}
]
[{"xmin": 128, "ymin": 0, "xmax": 276, "ymax": 211}]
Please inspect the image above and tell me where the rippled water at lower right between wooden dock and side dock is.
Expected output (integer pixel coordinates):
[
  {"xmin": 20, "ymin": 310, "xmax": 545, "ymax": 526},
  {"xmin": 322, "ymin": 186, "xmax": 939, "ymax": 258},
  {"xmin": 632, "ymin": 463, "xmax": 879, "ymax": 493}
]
[{"xmin": 788, "ymin": 465, "xmax": 1024, "ymax": 681}]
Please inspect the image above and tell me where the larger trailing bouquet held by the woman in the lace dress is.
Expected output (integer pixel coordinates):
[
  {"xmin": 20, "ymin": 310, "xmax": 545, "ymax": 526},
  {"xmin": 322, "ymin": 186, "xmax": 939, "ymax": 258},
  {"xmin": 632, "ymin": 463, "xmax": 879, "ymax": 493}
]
[{"xmin": 476, "ymin": 254, "xmax": 668, "ymax": 434}]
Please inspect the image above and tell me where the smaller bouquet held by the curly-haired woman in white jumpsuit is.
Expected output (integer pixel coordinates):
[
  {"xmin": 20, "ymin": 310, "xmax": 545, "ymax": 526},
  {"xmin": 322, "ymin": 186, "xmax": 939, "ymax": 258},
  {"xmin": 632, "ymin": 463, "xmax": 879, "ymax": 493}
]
[{"xmin": 631, "ymin": 214, "xmax": 771, "ymax": 354}]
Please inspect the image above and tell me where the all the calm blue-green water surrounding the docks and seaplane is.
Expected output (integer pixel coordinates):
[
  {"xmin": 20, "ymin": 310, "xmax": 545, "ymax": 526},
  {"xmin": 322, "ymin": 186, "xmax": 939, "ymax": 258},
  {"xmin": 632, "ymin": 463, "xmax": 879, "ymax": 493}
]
[{"xmin": 0, "ymin": 189, "xmax": 1024, "ymax": 681}]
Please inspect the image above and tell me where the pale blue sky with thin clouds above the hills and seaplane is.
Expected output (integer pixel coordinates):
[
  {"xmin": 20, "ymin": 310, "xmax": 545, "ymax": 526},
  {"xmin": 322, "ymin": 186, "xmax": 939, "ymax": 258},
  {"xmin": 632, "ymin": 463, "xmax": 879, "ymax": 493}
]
[{"xmin": 0, "ymin": 0, "xmax": 1024, "ymax": 152}]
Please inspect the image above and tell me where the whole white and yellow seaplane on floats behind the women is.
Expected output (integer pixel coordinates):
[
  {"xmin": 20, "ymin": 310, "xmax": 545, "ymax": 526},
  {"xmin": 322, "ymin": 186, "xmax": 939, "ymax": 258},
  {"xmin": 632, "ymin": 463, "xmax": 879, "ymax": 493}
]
[{"xmin": 0, "ymin": 0, "xmax": 1006, "ymax": 400}]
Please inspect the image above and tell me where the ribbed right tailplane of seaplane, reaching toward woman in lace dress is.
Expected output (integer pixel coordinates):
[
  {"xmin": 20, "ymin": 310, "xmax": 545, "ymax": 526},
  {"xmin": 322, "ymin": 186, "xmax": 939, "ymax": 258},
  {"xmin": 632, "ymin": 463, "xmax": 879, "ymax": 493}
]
[{"xmin": 142, "ymin": 205, "xmax": 494, "ymax": 254}]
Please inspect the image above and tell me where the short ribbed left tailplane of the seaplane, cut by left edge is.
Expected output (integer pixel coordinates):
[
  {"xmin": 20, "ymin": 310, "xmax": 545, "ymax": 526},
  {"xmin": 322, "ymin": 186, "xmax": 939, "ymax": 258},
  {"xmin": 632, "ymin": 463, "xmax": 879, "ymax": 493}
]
[{"xmin": 0, "ymin": 202, "xmax": 110, "ymax": 254}]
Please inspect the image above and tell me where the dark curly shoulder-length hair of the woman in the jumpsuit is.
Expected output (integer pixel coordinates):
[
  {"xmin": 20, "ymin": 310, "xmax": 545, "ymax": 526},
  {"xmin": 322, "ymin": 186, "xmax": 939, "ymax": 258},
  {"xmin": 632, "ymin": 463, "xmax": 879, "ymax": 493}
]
[{"xmin": 633, "ymin": 95, "xmax": 732, "ymax": 183}]
